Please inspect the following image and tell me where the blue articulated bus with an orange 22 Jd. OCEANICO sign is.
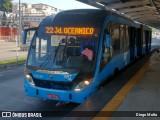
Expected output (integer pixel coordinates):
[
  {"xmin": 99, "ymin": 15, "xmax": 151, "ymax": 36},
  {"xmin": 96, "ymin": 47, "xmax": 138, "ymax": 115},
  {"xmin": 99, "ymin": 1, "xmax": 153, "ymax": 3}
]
[{"xmin": 24, "ymin": 9, "xmax": 151, "ymax": 103}]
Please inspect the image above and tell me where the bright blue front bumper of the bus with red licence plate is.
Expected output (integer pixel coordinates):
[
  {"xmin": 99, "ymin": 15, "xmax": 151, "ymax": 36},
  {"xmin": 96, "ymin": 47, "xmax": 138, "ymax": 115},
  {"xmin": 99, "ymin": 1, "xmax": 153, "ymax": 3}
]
[{"xmin": 24, "ymin": 80, "xmax": 95, "ymax": 103}]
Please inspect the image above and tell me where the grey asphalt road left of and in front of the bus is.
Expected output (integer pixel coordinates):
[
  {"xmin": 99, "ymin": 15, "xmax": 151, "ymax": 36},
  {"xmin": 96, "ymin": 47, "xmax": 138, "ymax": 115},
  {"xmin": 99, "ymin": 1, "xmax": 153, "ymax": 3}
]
[{"xmin": 0, "ymin": 66, "xmax": 78, "ymax": 120}]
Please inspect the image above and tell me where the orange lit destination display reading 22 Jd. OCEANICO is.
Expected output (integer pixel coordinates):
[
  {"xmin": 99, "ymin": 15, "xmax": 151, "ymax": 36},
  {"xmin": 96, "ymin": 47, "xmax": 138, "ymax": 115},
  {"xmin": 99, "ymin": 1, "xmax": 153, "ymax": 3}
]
[{"xmin": 45, "ymin": 27, "xmax": 94, "ymax": 35}]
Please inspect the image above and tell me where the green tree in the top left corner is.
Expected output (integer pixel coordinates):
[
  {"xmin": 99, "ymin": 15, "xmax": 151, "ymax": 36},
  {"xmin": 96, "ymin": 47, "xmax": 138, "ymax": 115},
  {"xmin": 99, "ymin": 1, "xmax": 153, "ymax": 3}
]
[{"xmin": 0, "ymin": 0, "xmax": 12, "ymax": 12}]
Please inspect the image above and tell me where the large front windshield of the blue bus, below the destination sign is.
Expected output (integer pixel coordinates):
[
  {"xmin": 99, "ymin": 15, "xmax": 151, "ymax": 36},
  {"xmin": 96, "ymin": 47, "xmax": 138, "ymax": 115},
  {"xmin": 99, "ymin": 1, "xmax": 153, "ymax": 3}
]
[{"xmin": 27, "ymin": 34, "xmax": 99, "ymax": 72}]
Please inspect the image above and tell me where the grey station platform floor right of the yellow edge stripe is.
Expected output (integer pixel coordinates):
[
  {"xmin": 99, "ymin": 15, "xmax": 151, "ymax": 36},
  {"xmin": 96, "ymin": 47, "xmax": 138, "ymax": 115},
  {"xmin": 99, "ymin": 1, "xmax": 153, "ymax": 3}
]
[{"xmin": 110, "ymin": 52, "xmax": 160, "ymax": 120}]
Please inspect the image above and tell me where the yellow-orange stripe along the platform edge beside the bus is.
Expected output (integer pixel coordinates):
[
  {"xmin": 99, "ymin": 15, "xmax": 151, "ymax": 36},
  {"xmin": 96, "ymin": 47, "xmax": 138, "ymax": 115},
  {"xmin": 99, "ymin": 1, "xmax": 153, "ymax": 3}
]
[{"xmin": 93, "ymin": 61, "xmax": 150, "ymax": 120}]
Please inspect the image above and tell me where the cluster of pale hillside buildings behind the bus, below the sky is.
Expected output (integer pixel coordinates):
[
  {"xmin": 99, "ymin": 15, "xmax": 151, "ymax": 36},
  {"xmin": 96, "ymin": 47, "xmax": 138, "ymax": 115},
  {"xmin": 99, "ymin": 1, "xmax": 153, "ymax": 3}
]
[{"xmin": 12, "ymin": 3, "xmax": 60, "ymax": 27}]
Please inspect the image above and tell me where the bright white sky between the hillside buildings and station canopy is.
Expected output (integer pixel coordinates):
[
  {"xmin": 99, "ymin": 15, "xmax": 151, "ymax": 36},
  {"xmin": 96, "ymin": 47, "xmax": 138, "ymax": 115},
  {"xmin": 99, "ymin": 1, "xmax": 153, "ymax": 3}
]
[{"xmin": 13, "ymin": 0, "xmax": 96, "ymax": 10}]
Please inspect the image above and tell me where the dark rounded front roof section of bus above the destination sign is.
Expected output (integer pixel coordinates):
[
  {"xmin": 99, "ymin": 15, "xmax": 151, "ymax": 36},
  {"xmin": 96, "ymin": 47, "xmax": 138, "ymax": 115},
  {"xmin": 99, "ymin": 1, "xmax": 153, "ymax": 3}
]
[{"xmin": 40, "ymin": 9, "xmax": 107, "ymax": 27}]
